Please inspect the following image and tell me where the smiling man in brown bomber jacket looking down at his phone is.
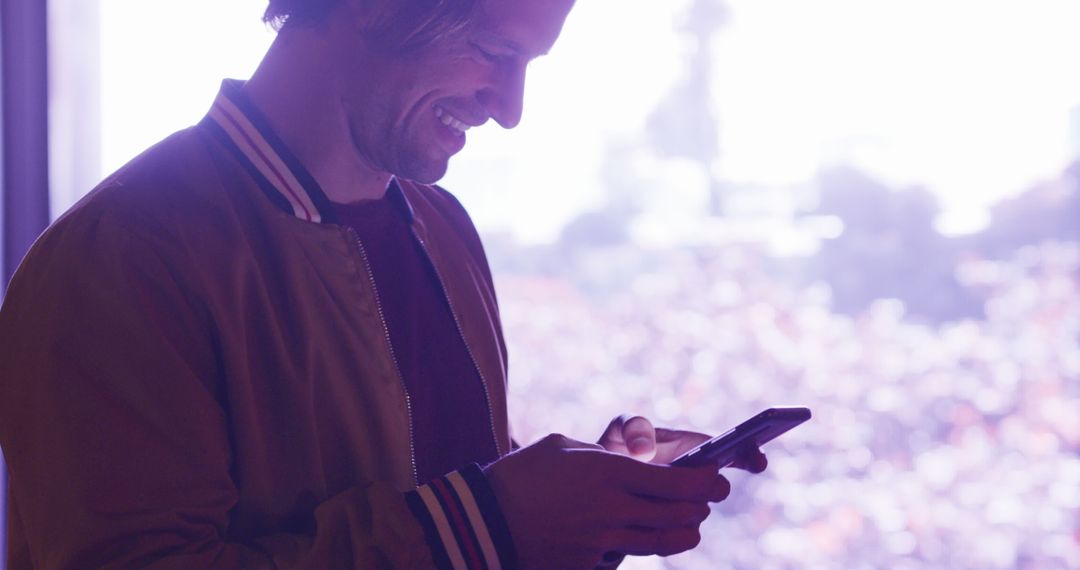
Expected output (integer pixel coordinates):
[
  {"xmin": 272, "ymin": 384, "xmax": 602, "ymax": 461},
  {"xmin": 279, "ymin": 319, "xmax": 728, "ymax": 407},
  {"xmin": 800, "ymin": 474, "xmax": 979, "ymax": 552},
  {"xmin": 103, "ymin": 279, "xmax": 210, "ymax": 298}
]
[{"xmin": 0, "ymin": 0, "xmax": 764, "ymax": 569}]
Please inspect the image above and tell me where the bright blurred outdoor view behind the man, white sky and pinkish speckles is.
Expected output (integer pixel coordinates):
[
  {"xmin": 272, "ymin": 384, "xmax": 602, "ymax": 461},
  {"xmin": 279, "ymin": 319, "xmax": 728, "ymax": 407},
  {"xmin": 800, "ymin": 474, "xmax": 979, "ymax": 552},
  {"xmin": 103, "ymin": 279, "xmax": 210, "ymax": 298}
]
[{"xmin": 27, "ymin": 0, "xmax": 1080, "ymax": 569}]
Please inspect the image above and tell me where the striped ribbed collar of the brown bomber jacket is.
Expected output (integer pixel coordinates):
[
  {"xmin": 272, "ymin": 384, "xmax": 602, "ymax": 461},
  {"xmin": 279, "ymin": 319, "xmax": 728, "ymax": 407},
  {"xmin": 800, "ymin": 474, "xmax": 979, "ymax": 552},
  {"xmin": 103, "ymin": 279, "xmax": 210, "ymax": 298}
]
[{"xmin": 201, "ymin": 79, "xmax": 414, "ymax": 223}]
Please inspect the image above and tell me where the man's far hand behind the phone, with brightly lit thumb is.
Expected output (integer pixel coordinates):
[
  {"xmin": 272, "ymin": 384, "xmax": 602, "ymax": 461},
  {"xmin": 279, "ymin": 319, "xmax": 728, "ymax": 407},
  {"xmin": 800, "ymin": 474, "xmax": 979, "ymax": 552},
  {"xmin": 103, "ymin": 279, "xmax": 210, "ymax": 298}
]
[{"xmin": 597, "ymin": 413, "xmax": 769, "ymax": 473}]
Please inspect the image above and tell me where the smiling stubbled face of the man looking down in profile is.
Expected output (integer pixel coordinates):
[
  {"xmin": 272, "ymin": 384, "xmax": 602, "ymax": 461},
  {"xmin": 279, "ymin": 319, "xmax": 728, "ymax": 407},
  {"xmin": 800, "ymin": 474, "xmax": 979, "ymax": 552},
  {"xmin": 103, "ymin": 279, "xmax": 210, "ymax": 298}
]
[{"xmin": 339, "ymin": 0, "xmax": 573, "ymax": 184}]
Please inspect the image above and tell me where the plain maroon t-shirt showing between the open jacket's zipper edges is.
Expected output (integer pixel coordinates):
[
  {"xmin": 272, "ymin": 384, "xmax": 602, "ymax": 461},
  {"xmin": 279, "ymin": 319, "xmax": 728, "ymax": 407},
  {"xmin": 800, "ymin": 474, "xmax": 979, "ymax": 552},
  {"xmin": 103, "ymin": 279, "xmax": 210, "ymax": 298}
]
[{"xmin": 334, "ymin": 189, "xmax": 498, "ymax": 485}]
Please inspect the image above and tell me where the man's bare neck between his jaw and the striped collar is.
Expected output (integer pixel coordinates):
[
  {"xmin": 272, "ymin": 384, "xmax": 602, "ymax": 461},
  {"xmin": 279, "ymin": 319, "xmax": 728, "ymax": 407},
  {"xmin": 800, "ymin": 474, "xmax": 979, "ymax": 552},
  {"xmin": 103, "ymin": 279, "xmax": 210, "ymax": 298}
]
[{"xmin": 244, "ymin": 29, "xmax": 390, "ymax": 203}]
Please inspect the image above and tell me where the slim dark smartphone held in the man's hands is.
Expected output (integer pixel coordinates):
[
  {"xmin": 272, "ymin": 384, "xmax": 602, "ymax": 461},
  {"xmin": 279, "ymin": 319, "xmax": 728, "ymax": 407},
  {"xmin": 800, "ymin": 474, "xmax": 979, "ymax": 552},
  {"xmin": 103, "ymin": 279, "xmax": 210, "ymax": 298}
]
[{"xmin": 671, "ymin": 407, "xmax": 810, "ymax": 469}]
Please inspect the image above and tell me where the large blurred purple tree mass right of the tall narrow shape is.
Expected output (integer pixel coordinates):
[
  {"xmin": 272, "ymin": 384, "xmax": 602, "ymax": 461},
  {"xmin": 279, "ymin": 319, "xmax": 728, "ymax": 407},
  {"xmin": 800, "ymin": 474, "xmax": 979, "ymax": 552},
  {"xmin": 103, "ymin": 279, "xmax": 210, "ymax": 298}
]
[{"xmin": 810, "ymin": 167, "xmax": 982, "ymax": 322}]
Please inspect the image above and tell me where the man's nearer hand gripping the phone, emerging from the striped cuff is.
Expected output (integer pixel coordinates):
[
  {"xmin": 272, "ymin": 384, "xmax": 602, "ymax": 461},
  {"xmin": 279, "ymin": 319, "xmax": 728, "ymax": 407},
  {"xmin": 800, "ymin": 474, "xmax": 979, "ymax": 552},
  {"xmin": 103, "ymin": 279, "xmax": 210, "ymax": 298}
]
[{"xmin": 485, "ymin": 435, "xmax": 730, "ymax": 569}]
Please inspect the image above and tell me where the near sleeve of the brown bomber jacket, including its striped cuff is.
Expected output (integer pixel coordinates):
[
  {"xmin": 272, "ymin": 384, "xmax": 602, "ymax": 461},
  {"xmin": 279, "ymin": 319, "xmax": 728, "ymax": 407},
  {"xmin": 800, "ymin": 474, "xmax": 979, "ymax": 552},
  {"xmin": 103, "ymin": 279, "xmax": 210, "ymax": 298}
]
[{"xmin": 0, "ymin": 212, "xmax": 514, "ymax": 570}]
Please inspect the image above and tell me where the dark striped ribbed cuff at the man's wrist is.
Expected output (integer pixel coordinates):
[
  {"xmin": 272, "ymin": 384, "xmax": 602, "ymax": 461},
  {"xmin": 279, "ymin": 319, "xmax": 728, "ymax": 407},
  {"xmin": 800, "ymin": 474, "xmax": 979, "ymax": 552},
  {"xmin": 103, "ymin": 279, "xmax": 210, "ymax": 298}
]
[{"xmin": 405, "ymin": 463, "xmax": 517, "ymax": 570}]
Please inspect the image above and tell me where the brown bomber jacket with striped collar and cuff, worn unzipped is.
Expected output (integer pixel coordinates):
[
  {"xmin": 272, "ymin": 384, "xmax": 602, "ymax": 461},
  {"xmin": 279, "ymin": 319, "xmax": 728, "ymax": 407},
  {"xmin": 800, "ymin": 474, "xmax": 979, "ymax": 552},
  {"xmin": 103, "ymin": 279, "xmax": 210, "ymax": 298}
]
[{"xmin": 0, "ymin": 81, "xmax": 514, "ymax": 569}]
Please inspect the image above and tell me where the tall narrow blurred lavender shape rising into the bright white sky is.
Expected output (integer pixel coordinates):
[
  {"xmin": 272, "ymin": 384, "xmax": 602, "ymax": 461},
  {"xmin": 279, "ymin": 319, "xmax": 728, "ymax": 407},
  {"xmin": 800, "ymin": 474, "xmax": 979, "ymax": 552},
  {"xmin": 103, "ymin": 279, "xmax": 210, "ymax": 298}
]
[{"xmin": 648, "ymin": 0, "xmax": 728, "ymax": 215}]
